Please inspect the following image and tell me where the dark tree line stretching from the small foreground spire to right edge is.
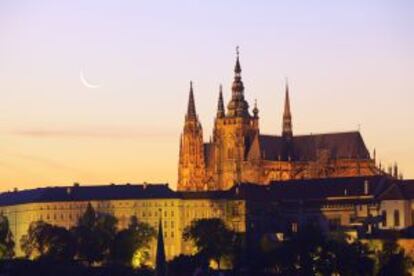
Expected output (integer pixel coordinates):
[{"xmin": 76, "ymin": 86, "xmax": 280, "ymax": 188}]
[{"xmin": 174, "ymin": 219, "xmax": 413, "ymax": 276}]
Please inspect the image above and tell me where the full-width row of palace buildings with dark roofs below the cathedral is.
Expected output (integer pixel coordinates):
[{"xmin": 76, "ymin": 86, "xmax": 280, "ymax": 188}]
[{"xmin": 0, "ymin": 175, "xmax": 414, "ymax": 265}]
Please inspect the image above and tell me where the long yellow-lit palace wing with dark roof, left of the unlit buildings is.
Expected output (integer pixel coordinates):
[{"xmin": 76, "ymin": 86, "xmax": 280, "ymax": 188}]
[{"xmin": 0, "ymin": 184, "xmax": 245, "ymax": 265}]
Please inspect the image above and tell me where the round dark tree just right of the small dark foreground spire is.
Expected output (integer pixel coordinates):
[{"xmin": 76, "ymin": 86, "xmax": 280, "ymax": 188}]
[{"xmin": 183, "ymin": 218, "xmax": 237, "ymax": 269}]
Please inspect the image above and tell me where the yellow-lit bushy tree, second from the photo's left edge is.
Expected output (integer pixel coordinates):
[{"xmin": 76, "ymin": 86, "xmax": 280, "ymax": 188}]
[{"xmin": 21, "ymin": 221, "xmax": 75, "ymax": 261}]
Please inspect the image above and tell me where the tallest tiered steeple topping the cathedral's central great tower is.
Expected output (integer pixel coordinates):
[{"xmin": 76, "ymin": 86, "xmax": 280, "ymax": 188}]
[{"xmin": 227, "ymin": 46, "xmax": 249, "ymax": 117}]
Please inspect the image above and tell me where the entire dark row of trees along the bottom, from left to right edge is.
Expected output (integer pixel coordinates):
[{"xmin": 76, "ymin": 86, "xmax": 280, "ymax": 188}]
[{"xmin": 0, "ymin": 209, "xmax": 413, "ymax": 276}]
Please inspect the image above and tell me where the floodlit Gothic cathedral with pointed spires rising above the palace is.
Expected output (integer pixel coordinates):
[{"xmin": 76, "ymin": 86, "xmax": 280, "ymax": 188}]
[{"xmin": 177, "ymin": 52, "xmax": 381, "ymax": 191}]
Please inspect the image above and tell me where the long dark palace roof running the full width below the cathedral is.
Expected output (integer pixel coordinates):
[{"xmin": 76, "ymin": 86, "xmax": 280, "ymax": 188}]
[{"xmin": 0, "ymin": 175, "xmax": 414, "ymax": 206}]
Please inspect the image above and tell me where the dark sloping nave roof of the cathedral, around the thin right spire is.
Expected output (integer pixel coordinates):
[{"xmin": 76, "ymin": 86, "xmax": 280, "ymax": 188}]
[{"xmin": 259, "ymin": 131, "xmax": 370, "ymax": 161}]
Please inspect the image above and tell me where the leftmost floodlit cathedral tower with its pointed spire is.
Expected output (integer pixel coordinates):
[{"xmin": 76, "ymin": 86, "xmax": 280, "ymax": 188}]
[{"xmin": 177, "ymin": 82, "xmax": 205, "ymax": 191}]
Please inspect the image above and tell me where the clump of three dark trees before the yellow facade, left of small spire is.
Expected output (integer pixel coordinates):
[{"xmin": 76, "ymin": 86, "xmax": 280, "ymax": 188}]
[{"xmin": 21, "ymin": 204, "xmax": 155, "ymax": 266}]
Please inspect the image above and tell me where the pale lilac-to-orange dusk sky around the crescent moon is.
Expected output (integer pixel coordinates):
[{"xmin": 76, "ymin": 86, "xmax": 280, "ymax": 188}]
[{"xmin": 0, "ymin": 0, "xmax": 414, "ymax": 191}]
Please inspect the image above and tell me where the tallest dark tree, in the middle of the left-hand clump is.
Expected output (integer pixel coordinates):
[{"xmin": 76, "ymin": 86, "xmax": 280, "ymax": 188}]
[{"xmin": 71, "ymin": 203, "xmax": 118, "ymax": 264}]
